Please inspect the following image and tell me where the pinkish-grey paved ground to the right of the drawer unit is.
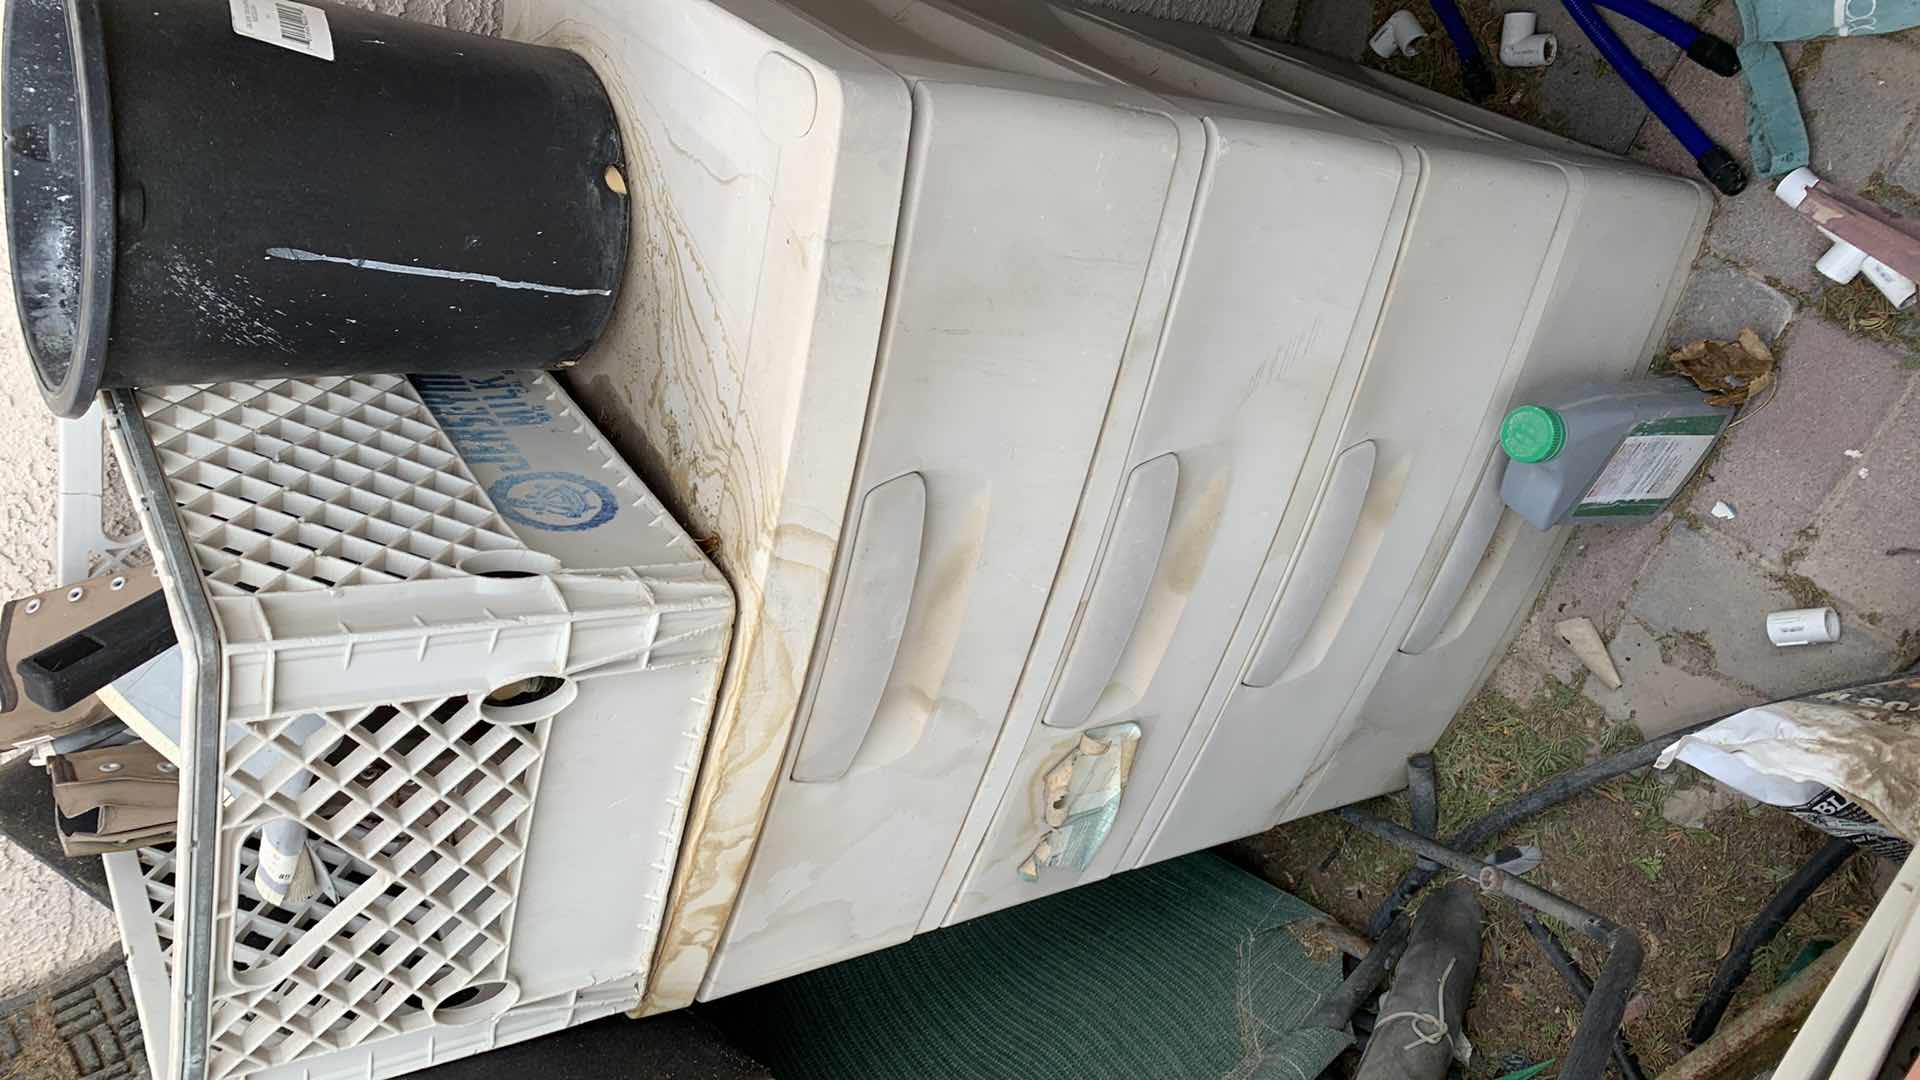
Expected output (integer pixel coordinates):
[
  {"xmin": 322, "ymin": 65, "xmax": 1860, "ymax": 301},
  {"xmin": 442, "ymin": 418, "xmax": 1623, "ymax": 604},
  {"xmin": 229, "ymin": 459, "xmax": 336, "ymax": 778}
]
[{"xmin": 1260, "ymin": 0, "xmax": 1920, "ymax": 734}]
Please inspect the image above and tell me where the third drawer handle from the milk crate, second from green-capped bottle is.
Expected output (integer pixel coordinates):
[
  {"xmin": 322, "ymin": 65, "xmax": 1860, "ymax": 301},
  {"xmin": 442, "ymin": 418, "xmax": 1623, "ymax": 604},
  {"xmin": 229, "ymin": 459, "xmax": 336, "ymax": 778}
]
[{"xmin": 1246, "ymin": 438, "xmax": 1379, "ymax": 686}]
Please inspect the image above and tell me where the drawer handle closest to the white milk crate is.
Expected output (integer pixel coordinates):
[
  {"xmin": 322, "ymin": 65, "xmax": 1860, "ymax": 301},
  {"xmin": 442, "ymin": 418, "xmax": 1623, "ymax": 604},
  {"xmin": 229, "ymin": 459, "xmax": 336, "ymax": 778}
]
[{"xmin": 793, "ymin": 473, "xmax": 927, "ymax": 784}]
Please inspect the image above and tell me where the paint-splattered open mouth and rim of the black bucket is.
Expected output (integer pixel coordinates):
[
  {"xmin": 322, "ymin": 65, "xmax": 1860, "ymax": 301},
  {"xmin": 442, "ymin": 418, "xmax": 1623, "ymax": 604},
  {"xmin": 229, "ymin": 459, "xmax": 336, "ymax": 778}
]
[{"xmin": 0, "ymin": 0, "xmax": 113, "ymax": 417}]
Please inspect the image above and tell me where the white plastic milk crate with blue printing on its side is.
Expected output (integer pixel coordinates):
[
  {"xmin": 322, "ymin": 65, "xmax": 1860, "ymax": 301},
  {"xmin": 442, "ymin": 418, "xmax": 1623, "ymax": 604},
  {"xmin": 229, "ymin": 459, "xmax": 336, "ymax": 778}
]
[{"xmin": 97, "ymin": 373, "xmax": 733, "ymax": 1080}]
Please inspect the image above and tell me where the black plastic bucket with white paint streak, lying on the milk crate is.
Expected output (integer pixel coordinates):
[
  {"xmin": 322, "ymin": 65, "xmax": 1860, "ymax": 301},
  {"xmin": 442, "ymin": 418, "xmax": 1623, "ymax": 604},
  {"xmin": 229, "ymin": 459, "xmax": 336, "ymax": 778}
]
[{"xmin": 4, "ymin": 0, "xmax": 628, "ymax": 417}]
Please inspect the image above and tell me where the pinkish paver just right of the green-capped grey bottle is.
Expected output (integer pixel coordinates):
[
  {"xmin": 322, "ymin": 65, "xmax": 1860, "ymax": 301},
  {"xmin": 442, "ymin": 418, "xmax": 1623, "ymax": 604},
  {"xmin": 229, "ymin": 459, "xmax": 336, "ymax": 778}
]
[{"xmin": 1690, "ymin": 319, "xmax": 1914, "ymax": 561}]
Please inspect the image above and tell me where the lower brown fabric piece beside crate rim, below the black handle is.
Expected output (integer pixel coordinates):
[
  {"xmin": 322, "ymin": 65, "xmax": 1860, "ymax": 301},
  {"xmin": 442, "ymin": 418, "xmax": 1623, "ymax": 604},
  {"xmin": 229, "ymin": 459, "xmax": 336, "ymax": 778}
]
[{"xmin": 46, "ymin": 742, "xmax": 180, "ymax": 855}]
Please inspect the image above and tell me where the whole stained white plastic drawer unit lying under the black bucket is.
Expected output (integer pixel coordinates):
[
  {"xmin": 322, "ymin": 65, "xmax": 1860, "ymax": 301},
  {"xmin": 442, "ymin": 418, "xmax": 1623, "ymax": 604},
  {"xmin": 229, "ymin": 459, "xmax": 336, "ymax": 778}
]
[{"xmin": 468, "ymin": 0, "xmax": 1709, "ymax": 1009}]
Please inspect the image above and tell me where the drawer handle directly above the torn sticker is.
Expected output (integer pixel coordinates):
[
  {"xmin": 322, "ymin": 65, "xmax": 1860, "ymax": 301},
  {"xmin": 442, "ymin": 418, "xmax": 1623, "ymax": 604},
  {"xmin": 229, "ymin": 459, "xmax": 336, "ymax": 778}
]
[{"xmin": 1046, "ymin": 454, "xmax": 1181, "ymax": 728}]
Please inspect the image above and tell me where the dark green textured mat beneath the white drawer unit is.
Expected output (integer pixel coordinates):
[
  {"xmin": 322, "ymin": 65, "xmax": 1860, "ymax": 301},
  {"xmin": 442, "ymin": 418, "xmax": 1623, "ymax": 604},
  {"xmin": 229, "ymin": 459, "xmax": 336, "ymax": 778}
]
[{"xmin": 712, "ymin": 855, "xmax": 1348, "ymax": 1080}]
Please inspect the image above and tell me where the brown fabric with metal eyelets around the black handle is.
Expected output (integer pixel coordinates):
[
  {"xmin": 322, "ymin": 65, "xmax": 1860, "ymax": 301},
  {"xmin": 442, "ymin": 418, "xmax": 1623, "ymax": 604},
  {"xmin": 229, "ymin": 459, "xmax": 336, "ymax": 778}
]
[{"xmin": 0, "ymin": 569, "xmax": 159, "ymax": 746}]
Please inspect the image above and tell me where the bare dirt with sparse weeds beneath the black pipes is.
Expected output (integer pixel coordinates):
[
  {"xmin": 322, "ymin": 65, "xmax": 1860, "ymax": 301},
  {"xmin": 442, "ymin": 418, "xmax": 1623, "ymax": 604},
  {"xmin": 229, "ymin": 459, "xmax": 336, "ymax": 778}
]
[{"xmin": 1227, "ymin": 680, "xmax": 1876, "ymax": 1078}]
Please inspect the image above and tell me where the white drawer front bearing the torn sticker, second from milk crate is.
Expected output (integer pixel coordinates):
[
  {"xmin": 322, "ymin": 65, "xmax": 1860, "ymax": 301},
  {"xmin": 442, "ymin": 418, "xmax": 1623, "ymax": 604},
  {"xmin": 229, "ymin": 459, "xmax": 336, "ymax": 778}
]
[{"xmin": 929, "ymin": 117, "xmax": 1413, "ymax": 920}]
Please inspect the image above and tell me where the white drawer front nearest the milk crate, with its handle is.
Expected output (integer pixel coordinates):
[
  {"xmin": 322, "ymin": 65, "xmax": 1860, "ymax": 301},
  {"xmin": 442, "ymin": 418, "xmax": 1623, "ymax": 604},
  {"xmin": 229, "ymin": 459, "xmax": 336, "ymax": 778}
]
[{"xmin": 708, "ymin": 0, "xmax": 1192, "ymax": 994}]
